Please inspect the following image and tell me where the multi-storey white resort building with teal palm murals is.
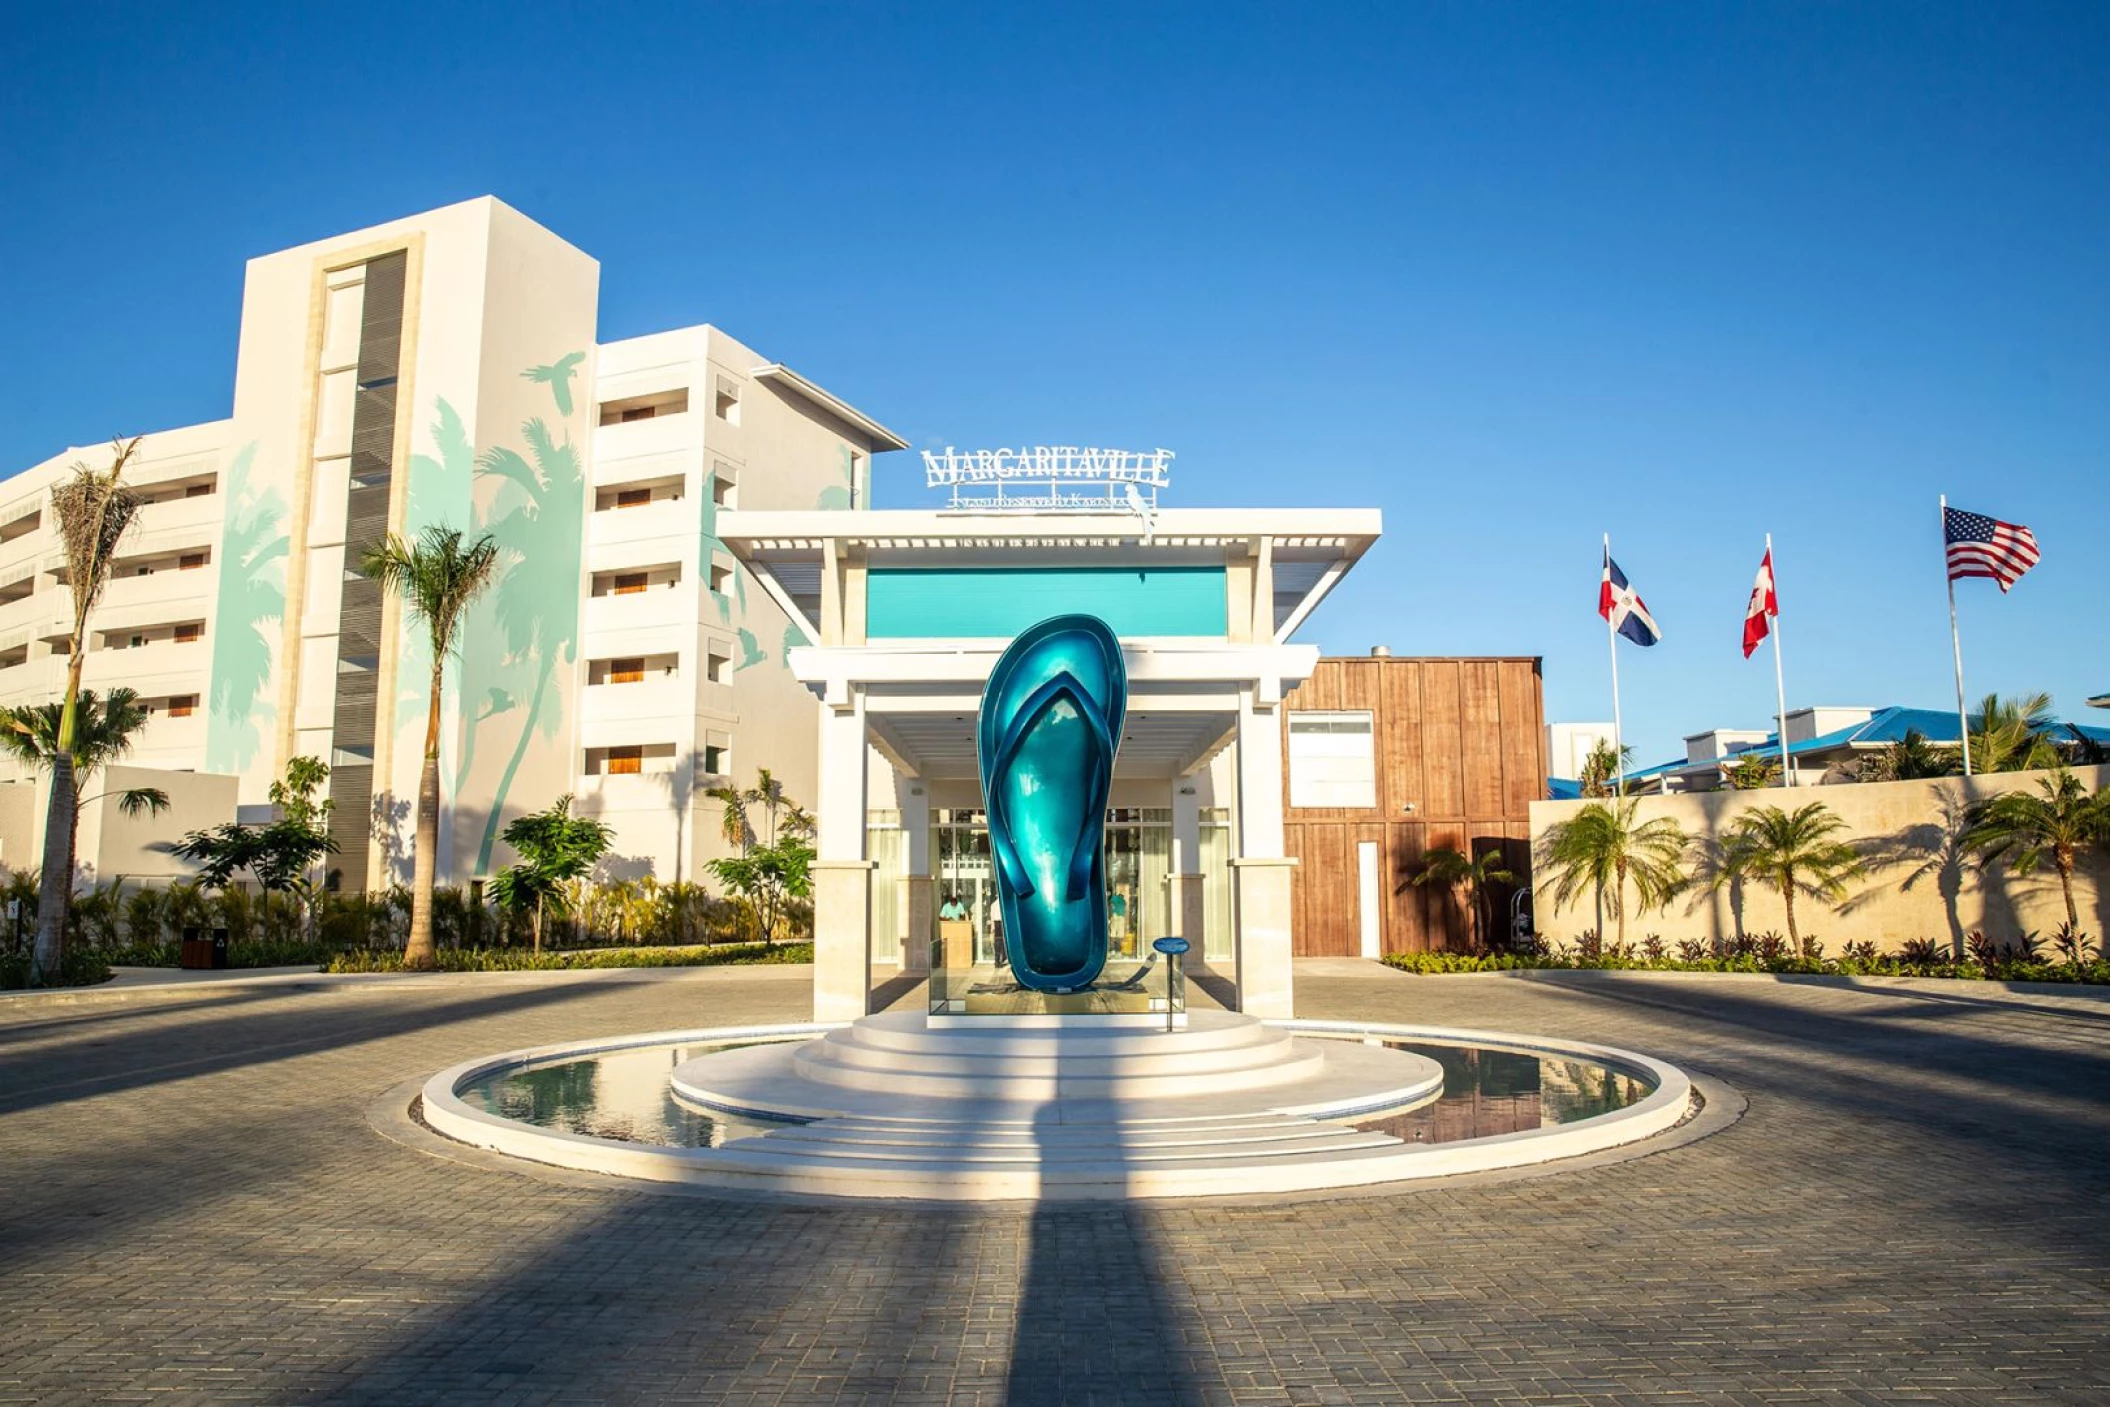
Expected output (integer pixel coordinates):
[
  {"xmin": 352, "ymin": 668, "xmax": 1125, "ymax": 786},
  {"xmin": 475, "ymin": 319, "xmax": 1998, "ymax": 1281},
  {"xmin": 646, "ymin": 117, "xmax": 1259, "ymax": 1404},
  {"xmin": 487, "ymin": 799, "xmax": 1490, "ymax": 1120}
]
[{"xmin": 0, "ymin": 198, "xmax": 903, "ymax": 890}]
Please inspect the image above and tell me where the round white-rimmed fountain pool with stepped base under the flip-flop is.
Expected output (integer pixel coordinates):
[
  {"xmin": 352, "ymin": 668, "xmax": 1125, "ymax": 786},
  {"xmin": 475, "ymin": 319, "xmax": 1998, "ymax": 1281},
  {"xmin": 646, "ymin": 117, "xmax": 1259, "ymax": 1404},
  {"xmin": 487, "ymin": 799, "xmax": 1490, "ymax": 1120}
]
[{"xmin": 422, "ymin": 1019, "xmax": 1694, "ymax": 1200}]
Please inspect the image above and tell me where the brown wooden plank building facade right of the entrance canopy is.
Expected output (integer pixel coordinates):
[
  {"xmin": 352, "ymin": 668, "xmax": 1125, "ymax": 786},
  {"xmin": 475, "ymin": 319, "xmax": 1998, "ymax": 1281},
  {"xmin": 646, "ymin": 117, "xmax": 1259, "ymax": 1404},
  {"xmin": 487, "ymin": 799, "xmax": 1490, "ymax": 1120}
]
[{"xmin": 1281, "ymin": 656, "xmax": 1547, "ymax": 958}]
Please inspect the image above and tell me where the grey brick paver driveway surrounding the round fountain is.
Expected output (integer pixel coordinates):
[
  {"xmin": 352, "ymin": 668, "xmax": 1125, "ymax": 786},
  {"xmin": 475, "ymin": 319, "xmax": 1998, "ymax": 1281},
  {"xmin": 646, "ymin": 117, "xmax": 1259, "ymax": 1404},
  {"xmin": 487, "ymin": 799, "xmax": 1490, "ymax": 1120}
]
[{"xmin": 0, "ymin": 964, "xmax": 2110, "ymax": 1403}]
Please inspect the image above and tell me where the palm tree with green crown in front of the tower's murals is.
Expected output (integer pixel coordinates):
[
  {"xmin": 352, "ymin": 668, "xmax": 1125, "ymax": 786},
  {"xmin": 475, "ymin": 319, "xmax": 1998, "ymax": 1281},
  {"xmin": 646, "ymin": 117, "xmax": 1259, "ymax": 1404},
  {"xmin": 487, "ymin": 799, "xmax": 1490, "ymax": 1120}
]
[{"xmin": 361, "ymin": 525, "xmax": 498, "ymax": 968}]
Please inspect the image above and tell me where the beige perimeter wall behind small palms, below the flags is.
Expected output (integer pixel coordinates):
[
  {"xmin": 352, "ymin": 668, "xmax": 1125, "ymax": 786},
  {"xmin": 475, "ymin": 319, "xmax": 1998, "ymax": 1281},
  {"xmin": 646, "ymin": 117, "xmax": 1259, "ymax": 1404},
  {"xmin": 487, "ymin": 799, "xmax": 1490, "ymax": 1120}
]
[{"xmin": 1532, "ymin": 768, "xmax": 2110, "ymax": 958}]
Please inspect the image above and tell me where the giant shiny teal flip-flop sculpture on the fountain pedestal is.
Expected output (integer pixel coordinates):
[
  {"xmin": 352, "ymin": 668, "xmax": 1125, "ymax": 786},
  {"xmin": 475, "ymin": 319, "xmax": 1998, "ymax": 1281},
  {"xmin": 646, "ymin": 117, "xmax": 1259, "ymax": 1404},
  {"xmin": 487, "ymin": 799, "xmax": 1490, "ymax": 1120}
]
[{"xmin": 975, "ymin": 616, "xmax": 1129, "ymax": 991}]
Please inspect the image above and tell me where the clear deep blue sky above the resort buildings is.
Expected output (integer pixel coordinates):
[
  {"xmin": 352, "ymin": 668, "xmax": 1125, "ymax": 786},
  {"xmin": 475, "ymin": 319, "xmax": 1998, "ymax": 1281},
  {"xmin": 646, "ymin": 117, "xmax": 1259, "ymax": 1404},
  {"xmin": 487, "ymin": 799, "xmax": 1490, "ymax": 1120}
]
[{"xmin": 0, "ymin": 0, "xmax": 2110, "ymax": 759}]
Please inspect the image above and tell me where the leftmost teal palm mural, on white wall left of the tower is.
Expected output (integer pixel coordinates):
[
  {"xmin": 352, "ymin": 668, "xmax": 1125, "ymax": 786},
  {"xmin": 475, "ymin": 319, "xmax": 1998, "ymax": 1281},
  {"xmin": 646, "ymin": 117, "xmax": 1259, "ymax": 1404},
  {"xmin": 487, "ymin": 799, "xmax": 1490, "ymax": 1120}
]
[{"xmin": 205, "ymin": 443, "xmax": 291, "ymax": 772}]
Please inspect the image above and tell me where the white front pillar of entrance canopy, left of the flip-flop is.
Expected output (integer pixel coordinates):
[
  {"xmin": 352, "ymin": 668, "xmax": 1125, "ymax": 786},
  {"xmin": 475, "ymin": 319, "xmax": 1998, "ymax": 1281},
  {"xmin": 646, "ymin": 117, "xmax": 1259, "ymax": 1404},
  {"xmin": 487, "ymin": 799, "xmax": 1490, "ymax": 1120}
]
[{"xmin": 812, "ymin": 686, "xmax": 874, "ymax": 1021}]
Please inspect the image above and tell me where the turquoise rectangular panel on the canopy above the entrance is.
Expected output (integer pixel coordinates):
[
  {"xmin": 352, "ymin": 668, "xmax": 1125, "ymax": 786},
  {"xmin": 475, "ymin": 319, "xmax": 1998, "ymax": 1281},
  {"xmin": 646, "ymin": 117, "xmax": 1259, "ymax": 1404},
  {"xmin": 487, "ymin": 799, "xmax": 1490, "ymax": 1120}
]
[{"xmin": 865, "ymin": 567, "xmax": 1230, "ymax": 639}]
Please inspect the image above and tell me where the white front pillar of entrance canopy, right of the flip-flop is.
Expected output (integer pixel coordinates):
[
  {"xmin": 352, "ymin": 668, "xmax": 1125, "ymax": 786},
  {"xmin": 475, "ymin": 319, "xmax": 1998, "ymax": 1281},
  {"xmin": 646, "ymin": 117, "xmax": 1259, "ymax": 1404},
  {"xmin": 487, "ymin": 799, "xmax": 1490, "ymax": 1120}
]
[{"xmin": 1230, "ymin": 679, "xmax": 1296, "ymax": 1017}]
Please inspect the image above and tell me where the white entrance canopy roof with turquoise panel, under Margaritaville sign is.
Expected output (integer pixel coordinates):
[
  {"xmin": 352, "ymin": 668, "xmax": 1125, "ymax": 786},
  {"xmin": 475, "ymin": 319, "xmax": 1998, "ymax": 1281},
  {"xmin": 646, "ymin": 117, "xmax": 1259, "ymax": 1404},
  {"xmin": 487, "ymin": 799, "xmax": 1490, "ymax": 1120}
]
[{"xmin": 717, "ymin": 508, "xmax": 1382, "ymax": 780}]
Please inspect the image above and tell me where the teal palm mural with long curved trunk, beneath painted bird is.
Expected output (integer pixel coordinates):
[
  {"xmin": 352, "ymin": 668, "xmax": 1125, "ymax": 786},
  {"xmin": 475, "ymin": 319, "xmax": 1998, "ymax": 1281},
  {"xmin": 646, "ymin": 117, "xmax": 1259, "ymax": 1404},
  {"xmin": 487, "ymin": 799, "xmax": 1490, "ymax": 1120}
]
[{"xmin": 462, "ymin": 409, "xmax": 587, "ymax": 873}]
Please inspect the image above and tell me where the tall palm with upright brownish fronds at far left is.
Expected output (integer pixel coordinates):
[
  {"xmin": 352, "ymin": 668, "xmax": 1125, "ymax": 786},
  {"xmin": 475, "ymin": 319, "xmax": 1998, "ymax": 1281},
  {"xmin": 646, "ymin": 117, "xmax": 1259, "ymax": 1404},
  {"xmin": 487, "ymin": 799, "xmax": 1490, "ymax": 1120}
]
[{"xmin": 30, "ymin": 439, "xmax": 139, "ymax": 987}]
